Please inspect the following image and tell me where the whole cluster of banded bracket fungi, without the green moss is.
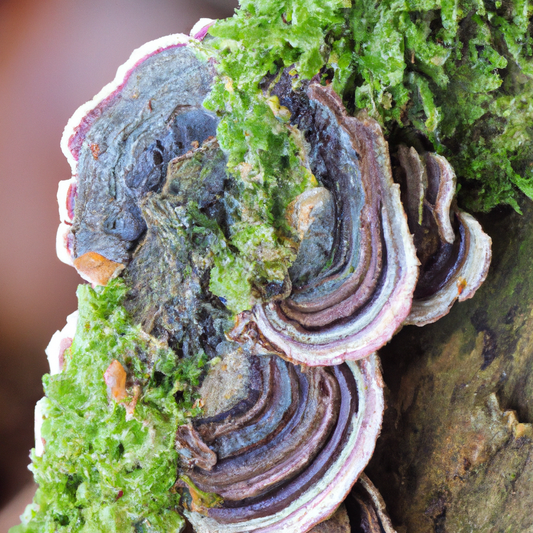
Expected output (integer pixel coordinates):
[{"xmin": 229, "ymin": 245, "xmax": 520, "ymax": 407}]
[{"xmin": 48, "ymin": 26, "xmax": 490, "ymax": 533}]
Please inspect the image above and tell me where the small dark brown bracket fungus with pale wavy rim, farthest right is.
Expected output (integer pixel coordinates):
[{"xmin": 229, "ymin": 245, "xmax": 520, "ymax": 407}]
[{"xmin": 395, "ymin": 146, "xmax": 491, "ymax": 326}]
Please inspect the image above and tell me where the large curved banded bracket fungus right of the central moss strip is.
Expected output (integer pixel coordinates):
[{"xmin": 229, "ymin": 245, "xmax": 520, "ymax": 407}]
[{"xmin": 234, "ymin": 74, "xmax": 418, "ymax": 366}]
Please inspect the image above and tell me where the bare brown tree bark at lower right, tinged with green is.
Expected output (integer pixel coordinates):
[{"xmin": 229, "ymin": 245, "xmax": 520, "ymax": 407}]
[{"xmin": 367, "ymin": 201, "xmax": 533, "ymax": 533}]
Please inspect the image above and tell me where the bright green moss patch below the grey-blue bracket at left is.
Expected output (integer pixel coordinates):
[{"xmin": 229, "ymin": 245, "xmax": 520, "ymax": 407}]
[{"xmin": 11, "ymin": 281, "xmax": 204, "ymax": 533}]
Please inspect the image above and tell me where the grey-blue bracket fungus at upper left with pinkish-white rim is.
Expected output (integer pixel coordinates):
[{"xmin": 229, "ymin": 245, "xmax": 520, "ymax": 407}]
[{"xmin": 56, "ymin": 30, "xmax": 218, "ymax": 285}]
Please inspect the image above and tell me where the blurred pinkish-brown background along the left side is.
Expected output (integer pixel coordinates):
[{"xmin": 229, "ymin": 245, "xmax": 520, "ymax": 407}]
[{"xmin": 0, "ymin": 0, "xmax": 237, "ymax": 533}]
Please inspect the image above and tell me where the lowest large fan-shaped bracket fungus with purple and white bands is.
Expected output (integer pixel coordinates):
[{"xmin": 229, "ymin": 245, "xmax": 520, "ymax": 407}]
[{"xmin": 182, "ymin": 354, "xmax": 384, "ymax": 533}]
